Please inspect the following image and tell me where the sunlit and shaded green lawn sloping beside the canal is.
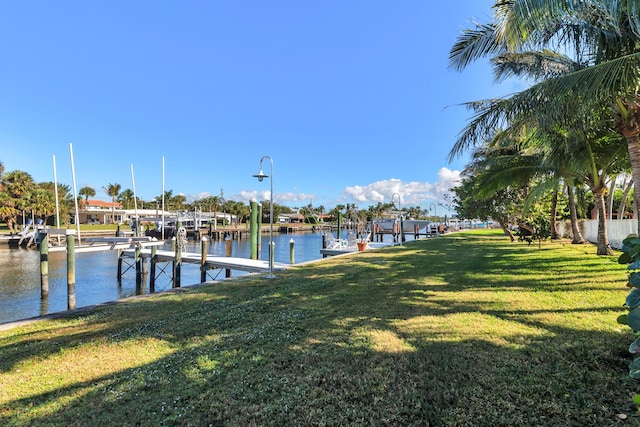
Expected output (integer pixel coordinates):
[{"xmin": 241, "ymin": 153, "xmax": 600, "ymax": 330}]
[{"xmin": 0, "ymin": 232, "xmax": 639, "ymax": 426}]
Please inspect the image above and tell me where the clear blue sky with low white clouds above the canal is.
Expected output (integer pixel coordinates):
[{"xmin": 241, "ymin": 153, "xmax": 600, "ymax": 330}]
[{"xmin": 0, "ymin": 0, "xmax": 517, "ymax": 214}]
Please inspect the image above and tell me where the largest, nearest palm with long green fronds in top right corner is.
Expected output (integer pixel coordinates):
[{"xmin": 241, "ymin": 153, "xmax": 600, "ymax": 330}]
[{"xmin": 450, "ymin": 0, "xmax": 640, "ymax": 229}]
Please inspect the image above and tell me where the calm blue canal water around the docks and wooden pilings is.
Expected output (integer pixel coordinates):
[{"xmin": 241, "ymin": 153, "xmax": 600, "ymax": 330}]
[{"xmin": 0, "ymin": 232, "xmax": 390, "ymax": 323}]
